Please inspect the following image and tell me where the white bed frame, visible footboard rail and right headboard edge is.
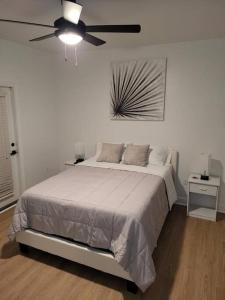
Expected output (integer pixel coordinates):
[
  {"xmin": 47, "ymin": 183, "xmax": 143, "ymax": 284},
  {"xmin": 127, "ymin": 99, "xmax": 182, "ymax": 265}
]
[{"xmin": 16, "ymin": 149, "xmax": 177, "ymax": 288}]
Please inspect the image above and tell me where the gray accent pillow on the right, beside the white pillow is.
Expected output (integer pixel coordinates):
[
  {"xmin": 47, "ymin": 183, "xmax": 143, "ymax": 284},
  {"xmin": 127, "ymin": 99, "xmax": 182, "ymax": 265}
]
[{"xmin": 123, "ymin": 144, "xmax": 149, "ymax": 167}]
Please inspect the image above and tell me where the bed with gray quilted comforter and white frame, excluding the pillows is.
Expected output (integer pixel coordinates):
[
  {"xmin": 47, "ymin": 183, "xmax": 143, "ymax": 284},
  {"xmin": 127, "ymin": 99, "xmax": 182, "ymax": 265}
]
[{"xmin": 9, "ymin": 149, "xmax": 177, "ymax": 292}]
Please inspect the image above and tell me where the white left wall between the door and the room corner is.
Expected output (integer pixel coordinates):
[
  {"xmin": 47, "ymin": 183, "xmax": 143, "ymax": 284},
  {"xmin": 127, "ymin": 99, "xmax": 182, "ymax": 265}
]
[{"xmin": 0, "ymin": 40, "xmax": 58, "ymax": 188}]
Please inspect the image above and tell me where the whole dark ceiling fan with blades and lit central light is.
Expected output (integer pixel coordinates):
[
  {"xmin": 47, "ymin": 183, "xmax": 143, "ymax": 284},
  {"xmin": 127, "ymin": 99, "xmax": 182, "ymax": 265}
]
[{"xmin": 0, "ymin": 0, "xmax": 141, "ymax": 46}]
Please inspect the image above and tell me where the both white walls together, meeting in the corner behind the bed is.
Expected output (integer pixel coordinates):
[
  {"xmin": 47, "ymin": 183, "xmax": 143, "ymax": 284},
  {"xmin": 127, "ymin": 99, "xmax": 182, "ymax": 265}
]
[{"xmin": 0, "ymin": 39, "xmax": 225, "ymax": 211}]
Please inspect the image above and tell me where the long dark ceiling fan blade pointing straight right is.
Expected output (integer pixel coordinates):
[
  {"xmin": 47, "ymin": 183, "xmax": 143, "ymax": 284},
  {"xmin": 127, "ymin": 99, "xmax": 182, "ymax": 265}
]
[{"xmin": 86, "ymin": 24, "xmax": 141, "ymax": 33}]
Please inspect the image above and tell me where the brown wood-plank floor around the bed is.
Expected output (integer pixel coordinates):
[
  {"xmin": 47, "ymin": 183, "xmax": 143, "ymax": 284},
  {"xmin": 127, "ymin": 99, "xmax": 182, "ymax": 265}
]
[{"xmin": 0, "ymin": 206, "xmax": 225, "ymax": 300}]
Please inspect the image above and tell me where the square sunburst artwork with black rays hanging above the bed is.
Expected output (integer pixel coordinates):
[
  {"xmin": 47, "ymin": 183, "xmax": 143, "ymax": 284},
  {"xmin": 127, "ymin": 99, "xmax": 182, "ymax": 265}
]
[{"xmin": 111, "ymin": 58, "xmax": 166, "ymax": 121}]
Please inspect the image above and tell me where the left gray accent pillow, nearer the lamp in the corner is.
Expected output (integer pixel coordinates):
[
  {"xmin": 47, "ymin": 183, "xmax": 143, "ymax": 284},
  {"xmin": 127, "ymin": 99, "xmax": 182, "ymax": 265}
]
[{"xmin": 96, "ymin": 143, "xmax": 124, "ymax": 163}]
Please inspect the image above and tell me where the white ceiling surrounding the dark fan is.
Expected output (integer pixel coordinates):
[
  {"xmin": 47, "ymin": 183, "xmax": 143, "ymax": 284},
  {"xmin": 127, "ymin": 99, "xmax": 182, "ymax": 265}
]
[{"xmin": 0, "ymin": 0, "xmax": 225, "ymax": 51}]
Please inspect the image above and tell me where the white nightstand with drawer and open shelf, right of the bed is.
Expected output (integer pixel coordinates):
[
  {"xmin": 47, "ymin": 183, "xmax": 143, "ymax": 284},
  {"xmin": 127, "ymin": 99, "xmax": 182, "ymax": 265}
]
[{"xmin": 187, "ymin": 174, "xmax": 220, "ymax": 221}]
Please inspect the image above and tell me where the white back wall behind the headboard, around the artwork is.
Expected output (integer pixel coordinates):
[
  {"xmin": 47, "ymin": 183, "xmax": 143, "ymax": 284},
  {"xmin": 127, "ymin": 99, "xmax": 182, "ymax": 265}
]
[{"xmin": 55, "ymin": 39, "xmax": 225, "ymax": 211}]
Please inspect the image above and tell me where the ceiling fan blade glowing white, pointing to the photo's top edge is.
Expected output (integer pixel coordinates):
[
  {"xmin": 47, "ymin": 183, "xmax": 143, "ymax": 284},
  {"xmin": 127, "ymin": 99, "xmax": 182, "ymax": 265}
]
[{"xmin": 63, "ymin": 1, "xmax": 82, "ymax": 24}]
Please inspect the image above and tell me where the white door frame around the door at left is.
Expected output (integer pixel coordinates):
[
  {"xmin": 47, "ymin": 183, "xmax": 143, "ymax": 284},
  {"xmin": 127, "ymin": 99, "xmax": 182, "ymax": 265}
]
[{"xmin": 0, "ymin": 81, "xmax": 26, "ymax": 209}]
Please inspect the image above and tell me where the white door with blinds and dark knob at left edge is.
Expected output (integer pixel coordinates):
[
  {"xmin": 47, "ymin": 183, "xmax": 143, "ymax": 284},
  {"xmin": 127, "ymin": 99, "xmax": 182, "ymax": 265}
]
[{"xmin": 0, "ymin": 87, "xmax": 20, "ymax": 209}]
